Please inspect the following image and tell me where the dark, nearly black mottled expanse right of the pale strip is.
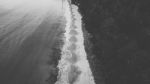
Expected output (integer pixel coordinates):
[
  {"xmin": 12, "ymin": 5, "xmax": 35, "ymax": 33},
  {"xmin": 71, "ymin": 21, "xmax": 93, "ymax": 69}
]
[{"xmin": 73, "ymin": 0, "xmax": 150, "ymax": 84}]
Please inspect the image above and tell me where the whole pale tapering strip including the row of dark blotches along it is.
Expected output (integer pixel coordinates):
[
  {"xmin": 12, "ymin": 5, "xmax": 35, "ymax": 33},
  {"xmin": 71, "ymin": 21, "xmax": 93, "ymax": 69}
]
[{"xmin": 55, "ymin": 0, "xmax": 95, "ymax": 84}]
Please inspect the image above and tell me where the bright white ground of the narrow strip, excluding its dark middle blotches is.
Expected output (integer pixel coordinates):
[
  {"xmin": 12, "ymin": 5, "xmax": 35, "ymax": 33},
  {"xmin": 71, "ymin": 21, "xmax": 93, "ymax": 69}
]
[{"xmin": 56, "ymin": 0, "xmax": 95, "ymax": 84}]
